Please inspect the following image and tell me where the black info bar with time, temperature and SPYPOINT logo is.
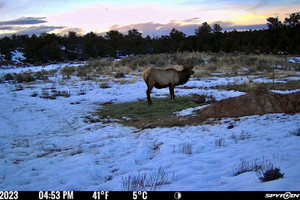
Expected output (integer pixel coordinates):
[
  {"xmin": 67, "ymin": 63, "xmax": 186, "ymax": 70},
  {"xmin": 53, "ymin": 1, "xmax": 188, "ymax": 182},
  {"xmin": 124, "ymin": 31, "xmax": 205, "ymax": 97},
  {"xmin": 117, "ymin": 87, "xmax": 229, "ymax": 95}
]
[{"xmin": 0, "ymin": 191, "xmax": 300, "ymax": 200}]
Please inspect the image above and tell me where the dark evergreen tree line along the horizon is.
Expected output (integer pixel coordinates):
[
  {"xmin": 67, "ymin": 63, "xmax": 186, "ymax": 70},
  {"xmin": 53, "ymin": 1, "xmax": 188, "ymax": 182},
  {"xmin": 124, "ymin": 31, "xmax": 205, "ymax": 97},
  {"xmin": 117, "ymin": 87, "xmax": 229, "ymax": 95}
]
[{"xmin": 0, "ymin": 13, "xmax": 300, "ymax": 63}]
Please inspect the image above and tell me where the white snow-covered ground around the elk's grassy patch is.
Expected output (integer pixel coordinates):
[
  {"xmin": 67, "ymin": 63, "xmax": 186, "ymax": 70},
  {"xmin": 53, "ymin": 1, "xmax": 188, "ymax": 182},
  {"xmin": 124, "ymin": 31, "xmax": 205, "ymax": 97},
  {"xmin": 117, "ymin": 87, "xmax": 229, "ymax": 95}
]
[{"xmin": 0, "ymin": 63, "xmax": 300, "ymax": 191}]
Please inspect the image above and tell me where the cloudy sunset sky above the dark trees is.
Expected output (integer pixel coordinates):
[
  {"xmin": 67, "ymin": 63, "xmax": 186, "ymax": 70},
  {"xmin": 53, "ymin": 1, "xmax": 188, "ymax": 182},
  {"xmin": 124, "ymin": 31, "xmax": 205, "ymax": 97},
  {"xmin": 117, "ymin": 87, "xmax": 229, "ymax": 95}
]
[{"xmin": 0, "ymin": 0, "xmax": 300, "ymax": 36}]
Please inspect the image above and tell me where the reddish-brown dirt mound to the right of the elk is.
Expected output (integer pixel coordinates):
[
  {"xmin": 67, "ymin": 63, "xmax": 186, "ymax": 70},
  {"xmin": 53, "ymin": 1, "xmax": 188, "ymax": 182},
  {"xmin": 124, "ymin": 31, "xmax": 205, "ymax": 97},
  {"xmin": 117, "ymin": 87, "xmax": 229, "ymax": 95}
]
[{"xmin": 197, "ymin": 85, "xmax": 300, "ymax": 119}]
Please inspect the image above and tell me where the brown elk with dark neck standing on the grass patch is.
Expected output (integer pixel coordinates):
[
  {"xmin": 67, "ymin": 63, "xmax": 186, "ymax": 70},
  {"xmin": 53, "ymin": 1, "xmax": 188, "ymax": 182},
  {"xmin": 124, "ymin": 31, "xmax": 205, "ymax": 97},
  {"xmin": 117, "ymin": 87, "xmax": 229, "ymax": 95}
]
[{"xmin": 142, "ymin": 54, "xmax": 194, "ymax": 105}]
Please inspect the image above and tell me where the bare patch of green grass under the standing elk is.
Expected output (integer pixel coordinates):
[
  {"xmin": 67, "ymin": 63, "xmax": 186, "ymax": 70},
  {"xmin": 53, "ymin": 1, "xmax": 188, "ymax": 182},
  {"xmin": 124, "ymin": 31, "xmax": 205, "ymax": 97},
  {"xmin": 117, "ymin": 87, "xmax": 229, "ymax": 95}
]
[{"xmin": 96, "ymin": 96, "xmax": 199, "ymax": 129}]
